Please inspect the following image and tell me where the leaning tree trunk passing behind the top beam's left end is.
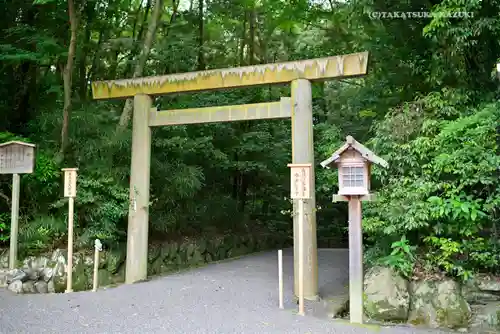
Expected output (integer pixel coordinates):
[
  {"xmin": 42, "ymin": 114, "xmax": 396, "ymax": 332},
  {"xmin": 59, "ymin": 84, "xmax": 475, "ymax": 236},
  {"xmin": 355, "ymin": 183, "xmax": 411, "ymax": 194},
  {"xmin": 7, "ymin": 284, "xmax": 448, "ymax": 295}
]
[{"xmin": 117, "ymin": 0, "xmax": 164, "ymax": 131}]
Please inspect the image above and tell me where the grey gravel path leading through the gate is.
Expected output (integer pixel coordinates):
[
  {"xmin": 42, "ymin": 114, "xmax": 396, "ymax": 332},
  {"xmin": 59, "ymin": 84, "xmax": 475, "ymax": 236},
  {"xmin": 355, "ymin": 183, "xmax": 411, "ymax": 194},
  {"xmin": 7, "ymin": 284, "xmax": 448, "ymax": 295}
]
[{"xmin": 0, "ymin": 249, "xmax": 446, "ymax": 334}]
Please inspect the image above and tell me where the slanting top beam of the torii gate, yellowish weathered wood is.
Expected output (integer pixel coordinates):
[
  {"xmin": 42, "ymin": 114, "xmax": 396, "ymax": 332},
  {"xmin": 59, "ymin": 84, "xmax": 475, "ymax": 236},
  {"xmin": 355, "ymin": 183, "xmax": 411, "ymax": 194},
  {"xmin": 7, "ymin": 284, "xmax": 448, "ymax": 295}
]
[{"xmin": 92, "ymin": 51, "xmax": 368, "ymax": 99}]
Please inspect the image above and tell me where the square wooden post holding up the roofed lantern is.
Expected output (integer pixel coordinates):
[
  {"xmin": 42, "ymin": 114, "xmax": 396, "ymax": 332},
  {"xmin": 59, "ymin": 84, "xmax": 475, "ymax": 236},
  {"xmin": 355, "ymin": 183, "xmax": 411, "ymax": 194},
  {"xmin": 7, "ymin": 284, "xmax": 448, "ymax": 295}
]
[{"xmin": 349, "ymin": 196, "xmax": 363, "ymax": 324}]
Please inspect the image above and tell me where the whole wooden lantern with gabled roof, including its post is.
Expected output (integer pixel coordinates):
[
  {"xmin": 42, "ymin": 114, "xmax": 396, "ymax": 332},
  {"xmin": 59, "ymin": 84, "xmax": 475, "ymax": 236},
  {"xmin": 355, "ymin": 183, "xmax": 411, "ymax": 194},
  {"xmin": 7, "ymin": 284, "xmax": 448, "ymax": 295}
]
[{"xmin": 321, "ymin": 136, "xmax": 388, "ymax": 324}]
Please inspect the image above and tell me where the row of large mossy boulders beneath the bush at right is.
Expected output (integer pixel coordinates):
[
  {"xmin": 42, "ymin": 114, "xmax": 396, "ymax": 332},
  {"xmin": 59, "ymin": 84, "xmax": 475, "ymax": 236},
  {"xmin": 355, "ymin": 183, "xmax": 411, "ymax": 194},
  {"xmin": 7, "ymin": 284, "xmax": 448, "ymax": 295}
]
[{"xmin": 364, "ymin": 267, "xmax": 500, "ymax": 333}]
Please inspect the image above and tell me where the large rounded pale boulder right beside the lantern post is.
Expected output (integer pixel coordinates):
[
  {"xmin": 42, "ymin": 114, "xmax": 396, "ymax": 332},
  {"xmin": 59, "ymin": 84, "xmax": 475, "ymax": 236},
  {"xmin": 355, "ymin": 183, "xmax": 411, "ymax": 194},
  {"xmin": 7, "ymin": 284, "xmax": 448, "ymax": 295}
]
[{"xmin": 364, "ymin": 266, "xmax": 410, "ymax": 321}]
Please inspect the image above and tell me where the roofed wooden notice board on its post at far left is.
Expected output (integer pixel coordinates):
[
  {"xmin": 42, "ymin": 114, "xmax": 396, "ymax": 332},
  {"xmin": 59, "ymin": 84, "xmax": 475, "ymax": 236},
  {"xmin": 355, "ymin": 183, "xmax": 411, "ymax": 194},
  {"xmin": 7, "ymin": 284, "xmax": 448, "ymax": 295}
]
[{"xmin": 0, "ymin": 141, "xmax": 35, "ymax": 269}]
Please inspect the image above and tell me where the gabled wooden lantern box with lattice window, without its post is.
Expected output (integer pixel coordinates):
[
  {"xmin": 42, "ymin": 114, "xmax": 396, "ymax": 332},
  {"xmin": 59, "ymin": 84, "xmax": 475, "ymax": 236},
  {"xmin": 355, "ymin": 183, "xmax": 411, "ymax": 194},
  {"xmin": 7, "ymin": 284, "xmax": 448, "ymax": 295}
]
[{"xmin": 321, "ymin": 136, "xmax": 388, "ymax": 196}]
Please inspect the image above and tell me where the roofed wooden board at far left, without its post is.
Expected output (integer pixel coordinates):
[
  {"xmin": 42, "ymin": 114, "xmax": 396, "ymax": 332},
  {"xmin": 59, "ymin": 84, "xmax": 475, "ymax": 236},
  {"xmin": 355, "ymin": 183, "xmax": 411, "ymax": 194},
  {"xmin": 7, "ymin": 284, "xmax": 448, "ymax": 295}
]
[{"xmin": 0, "ymin": 141, "xmax": 35, "ymax": 174}]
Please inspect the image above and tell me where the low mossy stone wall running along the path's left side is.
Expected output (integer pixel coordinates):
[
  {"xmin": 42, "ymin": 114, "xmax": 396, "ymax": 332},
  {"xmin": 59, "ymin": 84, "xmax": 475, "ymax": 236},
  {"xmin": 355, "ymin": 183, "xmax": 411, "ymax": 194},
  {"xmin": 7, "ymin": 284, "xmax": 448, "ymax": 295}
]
[{"xmin": 0, "ymin": 235, "xmax": 292, "ymax": 293}]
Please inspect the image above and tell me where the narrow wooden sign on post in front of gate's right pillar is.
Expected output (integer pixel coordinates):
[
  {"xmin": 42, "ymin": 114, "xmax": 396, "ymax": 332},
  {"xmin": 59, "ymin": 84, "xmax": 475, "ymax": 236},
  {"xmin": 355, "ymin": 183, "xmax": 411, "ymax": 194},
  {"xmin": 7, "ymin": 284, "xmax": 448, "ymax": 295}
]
[{"xmin": 288, "ymin": 164, "xmax": 312, "ymax": 315}]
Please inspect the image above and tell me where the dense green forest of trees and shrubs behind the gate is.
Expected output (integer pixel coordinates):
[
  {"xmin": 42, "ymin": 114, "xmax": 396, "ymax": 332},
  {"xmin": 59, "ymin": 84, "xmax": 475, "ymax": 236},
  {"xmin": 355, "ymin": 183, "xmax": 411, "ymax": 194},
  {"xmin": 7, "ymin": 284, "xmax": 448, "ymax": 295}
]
[{"xmin": 0, "ymin": 0, "xmax": 500, "ymax": 279}]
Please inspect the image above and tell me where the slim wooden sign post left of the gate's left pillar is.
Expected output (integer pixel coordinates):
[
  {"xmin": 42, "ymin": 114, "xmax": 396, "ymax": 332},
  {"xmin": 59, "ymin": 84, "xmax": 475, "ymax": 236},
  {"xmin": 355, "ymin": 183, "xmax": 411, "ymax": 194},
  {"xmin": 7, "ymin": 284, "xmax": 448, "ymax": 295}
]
[{"xmin": 62, "ymin": 168, "xmax": 78, "ymax": 293}]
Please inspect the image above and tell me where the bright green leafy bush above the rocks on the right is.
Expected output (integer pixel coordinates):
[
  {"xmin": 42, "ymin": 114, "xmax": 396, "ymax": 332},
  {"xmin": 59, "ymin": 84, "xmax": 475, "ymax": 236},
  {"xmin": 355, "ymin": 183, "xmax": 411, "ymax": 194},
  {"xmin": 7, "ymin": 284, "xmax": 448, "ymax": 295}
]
[{"xmin": 364, "ymin": 90, "xmax": 500, "ymax": 279}]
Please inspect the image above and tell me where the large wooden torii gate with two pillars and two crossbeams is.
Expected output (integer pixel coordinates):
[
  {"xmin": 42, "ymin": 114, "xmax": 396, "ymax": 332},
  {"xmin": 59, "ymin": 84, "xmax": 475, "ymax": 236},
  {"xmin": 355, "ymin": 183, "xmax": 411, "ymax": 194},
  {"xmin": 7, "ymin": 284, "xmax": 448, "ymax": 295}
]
[{"xmin": 92, "ymin": 52, "xmax": 368, "ymax": 300}]
